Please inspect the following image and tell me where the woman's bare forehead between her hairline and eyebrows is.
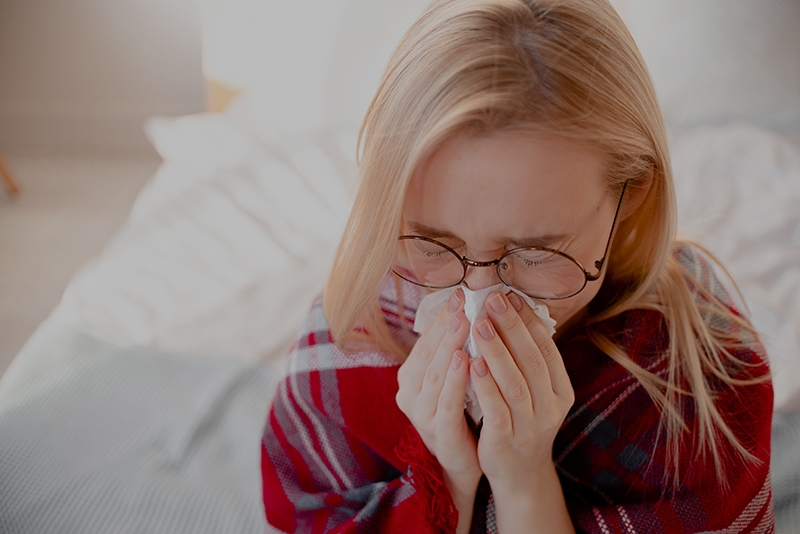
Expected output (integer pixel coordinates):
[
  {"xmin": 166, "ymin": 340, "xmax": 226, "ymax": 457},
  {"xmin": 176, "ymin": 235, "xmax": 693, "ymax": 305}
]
[{"xmin": 403, "ymin": 132, "xmax": 609, "ymax": 239}]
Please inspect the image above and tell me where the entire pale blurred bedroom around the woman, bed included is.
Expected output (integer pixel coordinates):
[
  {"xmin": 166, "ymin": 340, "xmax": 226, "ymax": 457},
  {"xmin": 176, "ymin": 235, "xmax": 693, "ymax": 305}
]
[{"xmin": 0, "ymin": 0, "xmax": 800, "ymax": 534}]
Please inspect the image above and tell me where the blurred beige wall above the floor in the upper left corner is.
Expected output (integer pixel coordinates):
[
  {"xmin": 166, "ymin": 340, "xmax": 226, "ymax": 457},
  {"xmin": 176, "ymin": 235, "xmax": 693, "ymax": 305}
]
[{"xmin": 0, "ymin": 0, "xmax": 204, "ymax": 153}]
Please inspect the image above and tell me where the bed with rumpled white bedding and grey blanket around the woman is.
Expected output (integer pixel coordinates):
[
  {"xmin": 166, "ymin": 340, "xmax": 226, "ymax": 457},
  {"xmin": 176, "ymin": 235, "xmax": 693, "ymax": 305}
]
[{"xmin": 0, "ymin": 0, "xmax": 800, "ymax": 534}]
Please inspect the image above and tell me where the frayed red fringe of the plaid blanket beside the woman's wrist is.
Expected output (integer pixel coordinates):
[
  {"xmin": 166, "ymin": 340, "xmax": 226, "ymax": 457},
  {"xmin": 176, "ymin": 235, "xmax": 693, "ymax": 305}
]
[{"xmin": 395, "ymin": 426, "xmax": 458, "ymax": 534}]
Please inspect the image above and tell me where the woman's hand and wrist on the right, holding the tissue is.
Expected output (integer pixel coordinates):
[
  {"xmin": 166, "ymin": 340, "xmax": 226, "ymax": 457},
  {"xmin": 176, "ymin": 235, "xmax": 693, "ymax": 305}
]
[{"xmin": 470, "ymin": 292, "xmax": 574, "ymax": 532}]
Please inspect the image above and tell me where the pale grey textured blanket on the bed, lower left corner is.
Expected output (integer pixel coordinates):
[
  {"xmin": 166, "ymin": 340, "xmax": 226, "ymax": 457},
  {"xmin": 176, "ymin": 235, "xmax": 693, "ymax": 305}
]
[{"xmin": 0, "ymin": 322, "xmax": 279, "ymax": 534}]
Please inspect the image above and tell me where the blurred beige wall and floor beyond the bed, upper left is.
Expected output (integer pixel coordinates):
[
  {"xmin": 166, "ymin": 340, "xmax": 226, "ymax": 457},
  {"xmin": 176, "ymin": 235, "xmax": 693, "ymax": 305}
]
[{"xmin": 0, "ymin": 0, "xmax": 206, "ymax": 374}]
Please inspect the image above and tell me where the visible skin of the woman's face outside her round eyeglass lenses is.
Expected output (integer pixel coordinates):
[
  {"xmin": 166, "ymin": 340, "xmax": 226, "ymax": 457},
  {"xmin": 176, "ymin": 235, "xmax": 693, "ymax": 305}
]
[{"xmin": 403, "ymin": 131, "xmax": 618, "ymax": 332}]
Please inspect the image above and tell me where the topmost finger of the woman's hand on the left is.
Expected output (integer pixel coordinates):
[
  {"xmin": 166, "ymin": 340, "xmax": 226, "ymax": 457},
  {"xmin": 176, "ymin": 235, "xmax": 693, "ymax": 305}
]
[{"xmin": 397, "ymin": 289, "xmax": 464, "ymax": 394}]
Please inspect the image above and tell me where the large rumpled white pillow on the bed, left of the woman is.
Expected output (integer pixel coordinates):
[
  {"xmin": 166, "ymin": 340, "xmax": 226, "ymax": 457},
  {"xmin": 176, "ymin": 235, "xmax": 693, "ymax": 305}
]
[{"xmin": 53, "ymin": 114, "xmax": 356, "ymax": 361}]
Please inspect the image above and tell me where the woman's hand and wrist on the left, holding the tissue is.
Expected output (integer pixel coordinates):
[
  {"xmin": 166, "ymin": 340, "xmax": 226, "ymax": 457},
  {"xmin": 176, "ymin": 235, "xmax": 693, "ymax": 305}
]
[{"xmin": 397, "ymin": 289, "xmax": 482, "ymax": 526}]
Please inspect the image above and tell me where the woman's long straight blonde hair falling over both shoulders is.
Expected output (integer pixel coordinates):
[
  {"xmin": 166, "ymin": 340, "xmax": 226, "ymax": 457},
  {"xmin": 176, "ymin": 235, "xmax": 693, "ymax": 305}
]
[{"xmin": 324, "ymin": 0, "xmax": 755, "ymax": 490}]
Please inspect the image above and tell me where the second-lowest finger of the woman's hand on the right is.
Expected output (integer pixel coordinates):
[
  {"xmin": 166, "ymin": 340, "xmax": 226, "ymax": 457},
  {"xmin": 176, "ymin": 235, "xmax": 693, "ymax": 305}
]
[{"xmin": 474, "ymin": 318, "xmax": 533, "ymax": 424}]
